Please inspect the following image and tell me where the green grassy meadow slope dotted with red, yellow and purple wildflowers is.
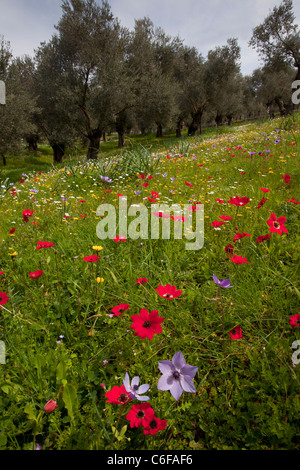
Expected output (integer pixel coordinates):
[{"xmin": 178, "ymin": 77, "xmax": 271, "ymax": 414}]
[{"xmin": 0, "ymin": 112, "xmax": 300, "ymax": 451}]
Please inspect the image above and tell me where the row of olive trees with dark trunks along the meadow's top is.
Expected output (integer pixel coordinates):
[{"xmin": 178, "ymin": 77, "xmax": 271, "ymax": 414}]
[{"xmin": 0, "ymin": 0, "xmax": 300, "ymax": 163}]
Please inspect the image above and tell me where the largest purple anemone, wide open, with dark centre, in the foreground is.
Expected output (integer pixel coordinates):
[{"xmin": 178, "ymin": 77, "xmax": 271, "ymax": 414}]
[{"xmin": 157, "ymin": 351, "xmax": 198, "ymax": 401}]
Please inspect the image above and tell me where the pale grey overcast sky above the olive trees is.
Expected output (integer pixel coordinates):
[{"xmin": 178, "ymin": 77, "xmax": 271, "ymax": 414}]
[{"xmin": 0, "ymin": 0, "xmax": 300, "ymax": 75}]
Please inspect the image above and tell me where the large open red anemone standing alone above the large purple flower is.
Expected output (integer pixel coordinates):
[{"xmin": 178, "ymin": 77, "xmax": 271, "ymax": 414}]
[{"xmin": 131, "ymin": 308, "xmax": 164, "ymax": 340}]
